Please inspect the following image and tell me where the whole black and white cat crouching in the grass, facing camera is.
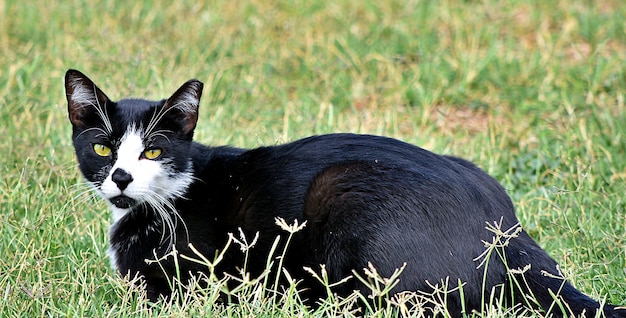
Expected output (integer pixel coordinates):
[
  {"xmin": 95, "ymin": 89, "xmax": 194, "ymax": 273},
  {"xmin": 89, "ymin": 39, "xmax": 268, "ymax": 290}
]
[{"xmin": 65, "ymin": 70, "xmax": 626, "ymax": 317}]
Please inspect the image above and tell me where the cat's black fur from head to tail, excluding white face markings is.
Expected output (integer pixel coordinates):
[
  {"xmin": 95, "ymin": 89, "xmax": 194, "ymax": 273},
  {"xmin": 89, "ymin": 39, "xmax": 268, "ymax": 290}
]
[{"xmin": 66, "ymin": 70, "xmax": 626, "ymax": 317}]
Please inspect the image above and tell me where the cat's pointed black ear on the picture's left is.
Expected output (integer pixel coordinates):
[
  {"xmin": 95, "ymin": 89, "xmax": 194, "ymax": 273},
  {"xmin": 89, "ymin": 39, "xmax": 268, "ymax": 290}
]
[{"xmin": 65, "ymin": 70, "xmax": 109, "ymax": 127}]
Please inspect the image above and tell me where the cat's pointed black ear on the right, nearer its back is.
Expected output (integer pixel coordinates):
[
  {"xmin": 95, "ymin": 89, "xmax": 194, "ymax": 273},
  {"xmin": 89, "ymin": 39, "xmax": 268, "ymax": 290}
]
[{"xmin": 163, "ymin": 80, "xmax": 204, "ymax": 135}]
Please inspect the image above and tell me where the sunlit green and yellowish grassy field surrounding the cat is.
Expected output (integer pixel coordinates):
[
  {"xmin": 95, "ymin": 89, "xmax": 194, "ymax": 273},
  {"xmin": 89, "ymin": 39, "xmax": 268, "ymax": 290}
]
[{"xmin": 0, "ymin": 0, "xmax": 626, "ymax": 317}]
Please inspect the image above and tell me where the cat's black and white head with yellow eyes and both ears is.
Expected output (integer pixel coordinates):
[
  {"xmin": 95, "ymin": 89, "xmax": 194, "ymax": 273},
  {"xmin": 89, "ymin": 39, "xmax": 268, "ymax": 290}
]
[{"xmin": 65, "ymin": 70, "xmax": 203, "ymax": 221}]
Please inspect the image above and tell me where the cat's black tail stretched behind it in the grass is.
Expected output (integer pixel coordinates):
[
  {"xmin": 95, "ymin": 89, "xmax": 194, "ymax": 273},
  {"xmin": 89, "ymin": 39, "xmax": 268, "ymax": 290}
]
[{"xmin": 506, "ymin": 231, "xmax": 626, "ymax": 318}]
